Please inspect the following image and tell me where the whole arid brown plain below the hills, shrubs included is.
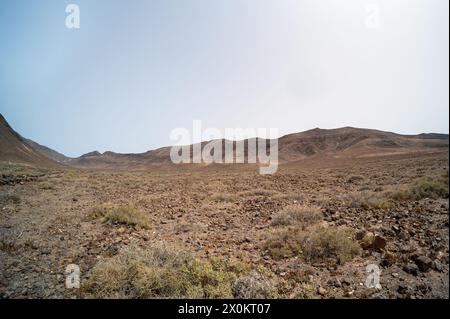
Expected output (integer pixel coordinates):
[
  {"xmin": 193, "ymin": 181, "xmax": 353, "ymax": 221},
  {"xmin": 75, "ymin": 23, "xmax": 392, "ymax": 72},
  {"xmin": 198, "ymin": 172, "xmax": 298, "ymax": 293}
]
[{"xmin": 0, "ymin": 151, "xmax": 449, "ymax": 298}]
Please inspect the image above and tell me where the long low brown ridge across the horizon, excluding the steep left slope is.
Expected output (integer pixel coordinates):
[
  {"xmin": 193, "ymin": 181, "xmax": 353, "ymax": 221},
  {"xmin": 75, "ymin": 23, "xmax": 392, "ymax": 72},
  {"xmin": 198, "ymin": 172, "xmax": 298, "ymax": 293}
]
[{"xmin": 69, "ymin": 127, "xmax": 449, "ymax": 168}]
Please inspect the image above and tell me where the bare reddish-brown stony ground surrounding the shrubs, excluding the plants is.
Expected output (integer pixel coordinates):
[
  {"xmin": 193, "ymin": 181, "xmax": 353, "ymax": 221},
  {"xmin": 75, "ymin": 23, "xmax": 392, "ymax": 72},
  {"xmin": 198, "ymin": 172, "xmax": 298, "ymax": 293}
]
[{"xmin": 0, "ymin": 153, "xmax": 449, "ymax": 298}]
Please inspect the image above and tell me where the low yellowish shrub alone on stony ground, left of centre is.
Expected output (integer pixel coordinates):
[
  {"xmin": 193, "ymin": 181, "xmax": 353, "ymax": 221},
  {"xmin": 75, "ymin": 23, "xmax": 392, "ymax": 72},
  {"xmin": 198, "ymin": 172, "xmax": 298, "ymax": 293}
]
[{"xmin": 90, "ymin": 204, "xmax": 150, "ymax": 228}]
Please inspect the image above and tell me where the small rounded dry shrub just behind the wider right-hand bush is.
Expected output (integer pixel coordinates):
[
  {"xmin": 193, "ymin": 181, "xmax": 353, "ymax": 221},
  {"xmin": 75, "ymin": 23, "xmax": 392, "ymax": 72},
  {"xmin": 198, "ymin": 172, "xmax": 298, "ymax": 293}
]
[{"xmin": 271, "ymin": 204, "xmax": 322, "ymax": 227}]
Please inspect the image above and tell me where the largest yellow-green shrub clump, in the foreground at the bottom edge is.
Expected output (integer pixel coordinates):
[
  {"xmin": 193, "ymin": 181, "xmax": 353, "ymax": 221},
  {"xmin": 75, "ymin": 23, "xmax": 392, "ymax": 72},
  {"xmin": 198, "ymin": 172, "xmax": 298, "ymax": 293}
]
[{"xmin": 82, "ymin": 245, "xmax": 250, "ymax": 298}]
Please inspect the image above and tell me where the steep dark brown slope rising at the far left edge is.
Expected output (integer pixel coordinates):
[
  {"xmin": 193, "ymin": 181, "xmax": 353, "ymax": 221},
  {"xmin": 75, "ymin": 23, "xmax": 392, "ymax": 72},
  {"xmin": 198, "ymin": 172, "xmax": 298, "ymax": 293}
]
[{"xmin": 0, "ymin": 114, "xmax": 58, "ymax": 166}]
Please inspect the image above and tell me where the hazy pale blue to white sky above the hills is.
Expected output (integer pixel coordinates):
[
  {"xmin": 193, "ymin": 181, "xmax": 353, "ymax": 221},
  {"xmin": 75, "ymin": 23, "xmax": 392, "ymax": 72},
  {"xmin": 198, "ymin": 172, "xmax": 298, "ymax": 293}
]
[{"xmin": 0, "ymin": 0, "xmax": 449, "ymax": 156}]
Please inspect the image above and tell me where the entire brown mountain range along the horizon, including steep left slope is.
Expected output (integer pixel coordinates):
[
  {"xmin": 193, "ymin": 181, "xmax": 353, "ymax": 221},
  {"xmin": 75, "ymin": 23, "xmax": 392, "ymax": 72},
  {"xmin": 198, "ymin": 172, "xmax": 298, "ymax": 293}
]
[{"xmin": 0, "ymin": 115, "xmax": 449, "ymax": 169}]
